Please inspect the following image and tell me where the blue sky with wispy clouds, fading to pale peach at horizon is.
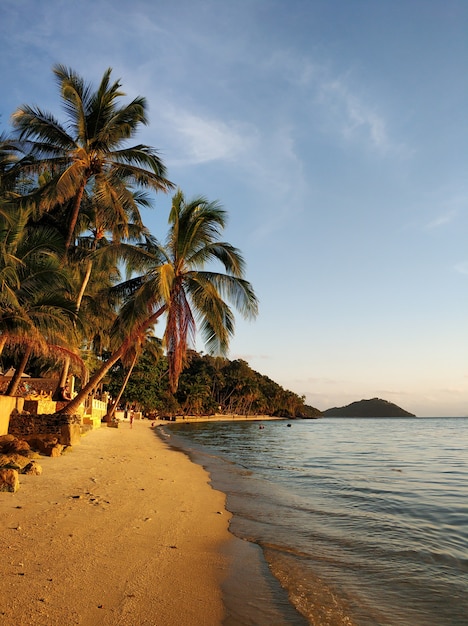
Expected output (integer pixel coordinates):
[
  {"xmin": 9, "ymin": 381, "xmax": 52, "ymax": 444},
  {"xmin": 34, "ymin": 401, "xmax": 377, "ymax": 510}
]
[{"xmin": 0, "ymin": 0, "xmax": 468, "ymax": 417}]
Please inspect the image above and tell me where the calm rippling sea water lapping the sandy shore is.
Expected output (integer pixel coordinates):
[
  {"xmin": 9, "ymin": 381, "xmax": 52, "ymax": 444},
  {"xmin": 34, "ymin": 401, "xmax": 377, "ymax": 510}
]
[{"xmin": 167, "ymin": 418, "xmax": 468, "ymax": 626}]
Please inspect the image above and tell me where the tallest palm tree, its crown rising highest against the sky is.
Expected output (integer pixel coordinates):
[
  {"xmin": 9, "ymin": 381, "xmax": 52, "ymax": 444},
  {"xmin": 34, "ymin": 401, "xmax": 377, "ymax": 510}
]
[{"xmin": 12, "ymin": 65, "xmax": 173, "ymax": 250}]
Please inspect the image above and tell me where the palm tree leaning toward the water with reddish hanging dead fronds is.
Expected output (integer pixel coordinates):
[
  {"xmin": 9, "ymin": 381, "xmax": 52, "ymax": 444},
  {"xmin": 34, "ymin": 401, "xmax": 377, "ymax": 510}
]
[{"xmin": 57, "ymin": 191, "xmax": 258, "ymax": 414}]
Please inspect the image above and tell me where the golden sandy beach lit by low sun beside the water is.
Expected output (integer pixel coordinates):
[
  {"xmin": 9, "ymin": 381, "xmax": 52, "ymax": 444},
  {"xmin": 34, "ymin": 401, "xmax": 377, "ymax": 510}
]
[{"xmin": 0, "ymin": 420, "xmax": 233, "ymax": 626}]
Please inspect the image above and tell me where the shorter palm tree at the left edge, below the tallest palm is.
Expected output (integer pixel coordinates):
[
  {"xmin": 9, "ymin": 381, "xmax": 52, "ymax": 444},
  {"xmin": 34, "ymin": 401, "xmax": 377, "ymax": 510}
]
[{"xmin": 0, "ymin": 206, "xmax": 81, "ymax": 395}]
